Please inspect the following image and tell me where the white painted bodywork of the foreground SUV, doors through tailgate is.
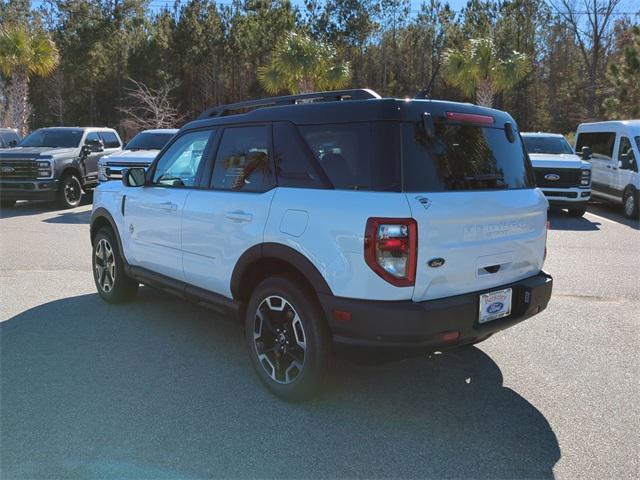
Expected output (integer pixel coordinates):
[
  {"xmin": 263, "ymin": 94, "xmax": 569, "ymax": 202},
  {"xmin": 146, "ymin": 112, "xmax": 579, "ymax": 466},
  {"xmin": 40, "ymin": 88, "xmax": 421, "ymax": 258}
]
[{"xmin": 94, "ymin": 182, "xmax": 548, "ymax": 301}]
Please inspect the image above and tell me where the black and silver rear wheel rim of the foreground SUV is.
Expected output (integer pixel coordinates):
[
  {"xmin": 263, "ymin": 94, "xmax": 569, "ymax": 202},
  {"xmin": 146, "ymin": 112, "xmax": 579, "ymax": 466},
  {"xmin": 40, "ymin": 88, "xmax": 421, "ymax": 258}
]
[{"xmin": 253, "ymin": 295, "xmax": 307, "ymax": 385}]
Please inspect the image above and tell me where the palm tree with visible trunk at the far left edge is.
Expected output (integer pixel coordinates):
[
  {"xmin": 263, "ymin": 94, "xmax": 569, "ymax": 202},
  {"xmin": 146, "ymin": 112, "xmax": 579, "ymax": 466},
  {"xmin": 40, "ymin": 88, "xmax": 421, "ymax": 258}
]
[{"xmin": 0, "ymin": 25, "xmax": 60, "ymax": 135}]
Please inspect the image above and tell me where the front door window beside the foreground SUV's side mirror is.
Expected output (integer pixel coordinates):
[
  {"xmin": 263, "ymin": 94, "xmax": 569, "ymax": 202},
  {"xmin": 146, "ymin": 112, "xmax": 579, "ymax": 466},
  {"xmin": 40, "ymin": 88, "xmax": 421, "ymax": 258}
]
[{"xmin": 153, "ymin": 130, "xmax": 213, "ymax": 187}]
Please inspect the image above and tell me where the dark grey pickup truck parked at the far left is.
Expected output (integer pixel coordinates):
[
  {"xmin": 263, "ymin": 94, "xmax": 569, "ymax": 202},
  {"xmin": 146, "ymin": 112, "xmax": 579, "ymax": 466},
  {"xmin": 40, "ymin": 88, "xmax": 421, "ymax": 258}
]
[{"xmin": 0, "ymin": 127, "xmax": 122, "ymax": 208}]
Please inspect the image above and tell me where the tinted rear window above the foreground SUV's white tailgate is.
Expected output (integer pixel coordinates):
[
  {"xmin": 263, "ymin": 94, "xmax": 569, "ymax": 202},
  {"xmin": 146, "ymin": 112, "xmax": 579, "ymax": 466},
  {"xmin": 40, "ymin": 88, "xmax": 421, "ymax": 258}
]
[{"xmin": 402, "ymin": 123, "xmax": 535, "ymax": 192}]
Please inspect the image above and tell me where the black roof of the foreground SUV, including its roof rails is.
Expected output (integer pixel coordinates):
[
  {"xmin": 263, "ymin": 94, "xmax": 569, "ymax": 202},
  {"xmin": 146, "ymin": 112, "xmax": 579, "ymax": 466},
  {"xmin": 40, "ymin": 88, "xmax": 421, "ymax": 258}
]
[{"xmin": 182, "ymin": 90, "xmax": 515, "ymax": 129}]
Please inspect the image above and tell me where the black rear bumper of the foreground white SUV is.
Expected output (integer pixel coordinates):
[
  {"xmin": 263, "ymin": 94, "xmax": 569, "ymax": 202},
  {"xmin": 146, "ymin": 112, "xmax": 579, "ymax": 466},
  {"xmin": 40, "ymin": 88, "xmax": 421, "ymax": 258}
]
[{"xmin": 319, "ymin": 272, "xmax": 553, "ymax": 349}]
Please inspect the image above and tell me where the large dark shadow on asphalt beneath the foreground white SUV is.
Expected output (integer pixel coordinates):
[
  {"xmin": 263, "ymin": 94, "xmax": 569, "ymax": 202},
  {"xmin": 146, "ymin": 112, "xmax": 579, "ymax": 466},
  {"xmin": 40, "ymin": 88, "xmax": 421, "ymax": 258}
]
[{"xmin": 0, "ymin": 288, "xmax": 560, "ymax": 479}]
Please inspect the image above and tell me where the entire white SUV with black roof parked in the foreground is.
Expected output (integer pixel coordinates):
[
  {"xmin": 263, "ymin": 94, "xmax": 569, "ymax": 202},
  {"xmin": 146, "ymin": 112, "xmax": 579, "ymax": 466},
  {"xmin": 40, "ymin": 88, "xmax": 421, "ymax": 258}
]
[{"xmin": 91, "ymin": 90, "xmax": 552, "ymax": 400}]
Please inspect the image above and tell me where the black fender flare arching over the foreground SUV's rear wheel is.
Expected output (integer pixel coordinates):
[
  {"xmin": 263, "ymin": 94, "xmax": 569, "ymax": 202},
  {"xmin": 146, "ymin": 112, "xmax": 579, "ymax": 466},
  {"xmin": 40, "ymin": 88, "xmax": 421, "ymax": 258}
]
[{"xmin": 231, "ymin": 242, "xmax": 333, "ymax": 299}]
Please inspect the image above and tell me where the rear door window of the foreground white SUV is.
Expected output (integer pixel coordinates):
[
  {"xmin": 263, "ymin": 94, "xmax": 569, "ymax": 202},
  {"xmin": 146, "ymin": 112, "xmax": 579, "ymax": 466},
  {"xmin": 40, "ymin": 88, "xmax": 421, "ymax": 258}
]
[{"xmin": 211, "ymin": 125, "xmax": 275, "ymax": 192}]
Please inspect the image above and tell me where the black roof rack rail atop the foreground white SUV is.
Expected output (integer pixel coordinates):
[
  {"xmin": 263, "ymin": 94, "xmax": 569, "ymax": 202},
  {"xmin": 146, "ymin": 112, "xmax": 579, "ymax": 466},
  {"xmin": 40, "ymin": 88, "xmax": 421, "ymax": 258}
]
[{"xmin": 198, "ymin": 88, "xmax": 382, "ymax": 120}]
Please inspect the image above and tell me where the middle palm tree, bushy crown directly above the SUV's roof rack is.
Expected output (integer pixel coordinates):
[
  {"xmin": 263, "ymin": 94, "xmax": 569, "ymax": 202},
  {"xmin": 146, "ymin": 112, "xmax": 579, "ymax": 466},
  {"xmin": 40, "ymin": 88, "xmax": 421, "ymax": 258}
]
[{"xmin": 258, "ymin": 32, "xmax": 351, "ymax": 94}]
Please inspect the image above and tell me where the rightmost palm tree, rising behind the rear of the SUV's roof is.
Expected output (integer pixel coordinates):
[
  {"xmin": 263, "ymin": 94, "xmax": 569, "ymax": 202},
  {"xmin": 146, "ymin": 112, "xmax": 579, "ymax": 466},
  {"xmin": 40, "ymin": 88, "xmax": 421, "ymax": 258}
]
[{"xmin": 442, "ymin": 38, "xmax": 531, "ymax": 107}]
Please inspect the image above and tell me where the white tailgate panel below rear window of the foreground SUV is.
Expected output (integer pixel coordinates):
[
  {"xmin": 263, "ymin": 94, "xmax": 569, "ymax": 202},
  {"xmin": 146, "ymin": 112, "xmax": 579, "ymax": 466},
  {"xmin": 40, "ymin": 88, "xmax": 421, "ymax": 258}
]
[{"xmin": 406, "ymin": 189, "xmax": 548, "ymax": 301}]
